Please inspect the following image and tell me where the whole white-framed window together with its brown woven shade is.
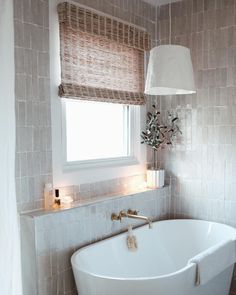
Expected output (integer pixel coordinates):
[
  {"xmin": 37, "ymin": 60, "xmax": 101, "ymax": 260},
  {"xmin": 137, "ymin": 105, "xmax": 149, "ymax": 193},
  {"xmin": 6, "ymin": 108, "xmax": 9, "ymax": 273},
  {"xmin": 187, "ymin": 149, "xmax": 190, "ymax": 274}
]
[{"xmin": 53, "ymin": 2, "xmax": 150, "ymax": 176}]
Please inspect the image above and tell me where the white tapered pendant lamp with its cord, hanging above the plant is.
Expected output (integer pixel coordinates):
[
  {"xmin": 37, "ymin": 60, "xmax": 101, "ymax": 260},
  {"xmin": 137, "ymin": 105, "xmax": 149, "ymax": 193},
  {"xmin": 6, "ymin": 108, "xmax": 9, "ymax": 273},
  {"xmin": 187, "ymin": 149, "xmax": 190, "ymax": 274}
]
[{"xmin": 144, "ymin": 4, "xmax": 196, "ymax": 95}]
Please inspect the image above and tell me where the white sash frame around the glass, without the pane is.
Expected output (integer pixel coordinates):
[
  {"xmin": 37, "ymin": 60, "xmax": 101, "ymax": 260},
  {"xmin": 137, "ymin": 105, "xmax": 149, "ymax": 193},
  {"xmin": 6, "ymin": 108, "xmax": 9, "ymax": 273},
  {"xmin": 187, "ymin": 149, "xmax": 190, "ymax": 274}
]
[{"xmin": 62, "ymin": 99, "xmax": 140, "ymax": 172}]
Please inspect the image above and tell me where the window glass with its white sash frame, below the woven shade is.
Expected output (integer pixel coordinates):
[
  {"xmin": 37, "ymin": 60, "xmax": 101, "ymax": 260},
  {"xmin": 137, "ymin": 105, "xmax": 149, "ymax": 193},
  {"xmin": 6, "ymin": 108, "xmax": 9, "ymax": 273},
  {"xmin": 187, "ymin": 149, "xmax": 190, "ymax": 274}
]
[{"xmin": 62, "ymin": 99, "xmax": 141, "ymax": 171}]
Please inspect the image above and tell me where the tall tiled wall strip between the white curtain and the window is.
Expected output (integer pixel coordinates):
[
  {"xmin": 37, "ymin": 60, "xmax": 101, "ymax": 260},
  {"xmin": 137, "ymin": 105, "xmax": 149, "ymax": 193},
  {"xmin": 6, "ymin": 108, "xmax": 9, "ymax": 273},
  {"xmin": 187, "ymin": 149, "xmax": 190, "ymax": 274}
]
[{"xmin": 14, "ymin": 0, "xmax": 52, "ymax": 211}]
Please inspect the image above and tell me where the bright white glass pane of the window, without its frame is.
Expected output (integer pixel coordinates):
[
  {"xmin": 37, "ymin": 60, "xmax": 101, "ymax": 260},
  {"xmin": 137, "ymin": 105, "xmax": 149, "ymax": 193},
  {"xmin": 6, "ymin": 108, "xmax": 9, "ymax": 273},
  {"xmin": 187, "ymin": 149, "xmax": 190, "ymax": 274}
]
[{"xmin": 65, "ymin": 100, "xmax": 130, "ymax": 162}]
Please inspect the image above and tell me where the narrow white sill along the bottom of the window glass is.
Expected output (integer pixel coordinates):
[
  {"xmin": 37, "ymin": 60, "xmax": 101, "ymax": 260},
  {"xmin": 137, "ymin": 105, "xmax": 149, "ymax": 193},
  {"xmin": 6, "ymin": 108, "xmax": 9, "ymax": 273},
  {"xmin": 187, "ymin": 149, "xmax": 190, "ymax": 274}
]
[{"xmin": 63, "ymin": 156, "xmax": 139, "ymax": 172}]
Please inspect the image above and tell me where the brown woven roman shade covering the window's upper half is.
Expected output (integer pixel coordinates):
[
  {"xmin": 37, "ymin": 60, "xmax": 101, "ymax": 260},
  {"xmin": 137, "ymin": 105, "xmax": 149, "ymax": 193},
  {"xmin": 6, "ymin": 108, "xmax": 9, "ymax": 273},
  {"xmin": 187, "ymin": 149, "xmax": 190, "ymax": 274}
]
[{"xmin": 58, "ymin": 2, "xmax": 150, "ymax": 105}]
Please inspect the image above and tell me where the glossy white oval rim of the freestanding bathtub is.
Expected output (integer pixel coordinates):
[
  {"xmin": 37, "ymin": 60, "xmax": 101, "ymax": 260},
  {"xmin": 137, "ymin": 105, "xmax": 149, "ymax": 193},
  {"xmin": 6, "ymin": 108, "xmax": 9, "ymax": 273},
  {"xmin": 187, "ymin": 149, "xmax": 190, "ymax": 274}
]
[{"xmin": 71, "ymin": 218, "xmax": 236, "ymax": 281}]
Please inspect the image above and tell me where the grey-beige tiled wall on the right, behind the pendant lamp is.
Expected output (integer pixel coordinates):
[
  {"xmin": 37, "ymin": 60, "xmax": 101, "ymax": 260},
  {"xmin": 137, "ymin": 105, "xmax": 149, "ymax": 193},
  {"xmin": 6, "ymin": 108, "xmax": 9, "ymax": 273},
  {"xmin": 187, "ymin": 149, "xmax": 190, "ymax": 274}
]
[{"xmin": 154, "ymin": 0, "xmax": 236, "ymax": 226}]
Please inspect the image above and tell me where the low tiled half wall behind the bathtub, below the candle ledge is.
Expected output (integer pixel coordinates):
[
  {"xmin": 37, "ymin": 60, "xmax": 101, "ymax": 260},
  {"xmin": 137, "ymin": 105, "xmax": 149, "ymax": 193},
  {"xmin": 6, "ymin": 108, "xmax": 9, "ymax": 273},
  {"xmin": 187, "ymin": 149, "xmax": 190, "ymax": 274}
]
[{"xmin": 21, "ymin": 187, "xmax": 170, "ymax": 295}]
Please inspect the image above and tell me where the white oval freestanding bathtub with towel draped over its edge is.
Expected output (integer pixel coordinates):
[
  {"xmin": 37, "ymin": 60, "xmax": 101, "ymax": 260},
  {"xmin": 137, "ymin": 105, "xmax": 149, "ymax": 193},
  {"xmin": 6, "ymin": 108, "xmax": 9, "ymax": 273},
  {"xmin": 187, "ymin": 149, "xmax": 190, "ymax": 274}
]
[{"xmin": 71, "ymin": 220, "xmax": 236, "ymax": 295}]
